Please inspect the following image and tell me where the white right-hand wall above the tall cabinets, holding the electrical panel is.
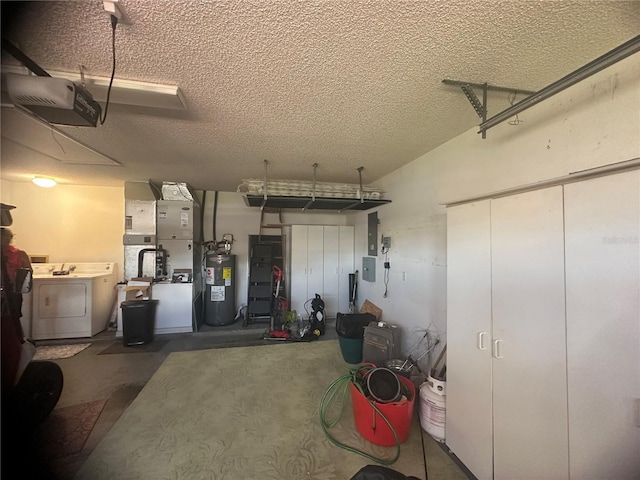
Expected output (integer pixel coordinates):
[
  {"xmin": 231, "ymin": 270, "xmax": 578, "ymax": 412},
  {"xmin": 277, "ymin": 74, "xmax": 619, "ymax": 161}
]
[{"xmin": 356, "ymin": 54, "xmax": 640, "ymax": 368}]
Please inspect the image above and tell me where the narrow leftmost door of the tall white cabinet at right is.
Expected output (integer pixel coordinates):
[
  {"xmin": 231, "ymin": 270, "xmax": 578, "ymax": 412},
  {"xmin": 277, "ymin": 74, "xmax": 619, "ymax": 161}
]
[{"xmin": 445, "ymin": 200, "xmax": 493, "ymax": 480}]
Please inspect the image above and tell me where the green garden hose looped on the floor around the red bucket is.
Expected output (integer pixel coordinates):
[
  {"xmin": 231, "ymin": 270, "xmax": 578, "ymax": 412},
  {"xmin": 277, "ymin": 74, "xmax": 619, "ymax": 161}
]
[{"xmin": 320, "ymin": 365, "xmax": 400, "ymax": 465}]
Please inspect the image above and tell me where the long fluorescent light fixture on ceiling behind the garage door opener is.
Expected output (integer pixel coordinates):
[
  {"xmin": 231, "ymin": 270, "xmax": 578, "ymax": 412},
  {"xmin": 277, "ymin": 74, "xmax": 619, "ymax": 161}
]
[{"xmin": 47, "ymin": 70, "xmax": 187, "ymax": 110}]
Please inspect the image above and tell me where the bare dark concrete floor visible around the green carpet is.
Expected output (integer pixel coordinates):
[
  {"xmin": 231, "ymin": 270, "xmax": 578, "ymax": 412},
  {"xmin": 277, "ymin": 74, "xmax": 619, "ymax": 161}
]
[{"xmin": 23, "ymin": 321, "xmax": 472, "ymax": 480}]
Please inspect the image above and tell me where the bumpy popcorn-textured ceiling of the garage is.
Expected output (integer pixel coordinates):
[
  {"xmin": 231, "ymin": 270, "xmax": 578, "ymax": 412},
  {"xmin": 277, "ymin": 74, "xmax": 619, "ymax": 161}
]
[{"xmin": 1, "ymin": 0, "xmax": 640, "ymax": 191}]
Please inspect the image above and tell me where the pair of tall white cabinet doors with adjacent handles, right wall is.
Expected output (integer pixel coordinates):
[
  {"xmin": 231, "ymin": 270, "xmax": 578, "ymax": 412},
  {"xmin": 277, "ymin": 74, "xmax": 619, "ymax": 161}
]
[{"xmin": 446, "ymin": 187, "xmax": 568, "ymax": 479}]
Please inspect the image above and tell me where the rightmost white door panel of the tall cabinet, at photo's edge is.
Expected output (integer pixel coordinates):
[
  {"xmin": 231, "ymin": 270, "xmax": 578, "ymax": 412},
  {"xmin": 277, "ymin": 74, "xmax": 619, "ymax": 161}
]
[{"xmin": 565, "ymin": 171, "xmax": 640, "ymax": 479}]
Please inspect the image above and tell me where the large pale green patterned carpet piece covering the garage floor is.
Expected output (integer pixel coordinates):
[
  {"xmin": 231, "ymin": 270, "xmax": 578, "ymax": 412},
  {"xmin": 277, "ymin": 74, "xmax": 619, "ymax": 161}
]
[{"xmin": 75, "ymin": 340, "xmax": 426, "ymax": 480}]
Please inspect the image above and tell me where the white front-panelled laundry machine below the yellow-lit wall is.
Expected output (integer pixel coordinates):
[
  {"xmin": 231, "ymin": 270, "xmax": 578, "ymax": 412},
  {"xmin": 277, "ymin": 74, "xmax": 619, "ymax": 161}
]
[{"xmin": 30, "ymin": 262, "xmax": 117, "ymax": 340}]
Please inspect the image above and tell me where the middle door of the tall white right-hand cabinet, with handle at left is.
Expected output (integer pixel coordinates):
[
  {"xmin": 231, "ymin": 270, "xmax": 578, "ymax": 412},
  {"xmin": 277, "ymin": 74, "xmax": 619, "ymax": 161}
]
[{"xmin": 492, "ymin": 186, "xmax": 569, "ymax": 480}]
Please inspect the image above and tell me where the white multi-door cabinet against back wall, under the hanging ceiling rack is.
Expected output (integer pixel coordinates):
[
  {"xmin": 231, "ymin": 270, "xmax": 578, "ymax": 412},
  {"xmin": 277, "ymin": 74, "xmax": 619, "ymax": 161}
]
[{"xmin": 290, "ymin": 225, "xmax": 354, "ymax": 318}]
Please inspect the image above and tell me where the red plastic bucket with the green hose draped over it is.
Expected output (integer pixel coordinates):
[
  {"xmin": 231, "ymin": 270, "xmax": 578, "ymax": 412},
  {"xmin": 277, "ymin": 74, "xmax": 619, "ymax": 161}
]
[{"xmin": 349, "ymin": 376, "xmax": 416, "ymax": 447}]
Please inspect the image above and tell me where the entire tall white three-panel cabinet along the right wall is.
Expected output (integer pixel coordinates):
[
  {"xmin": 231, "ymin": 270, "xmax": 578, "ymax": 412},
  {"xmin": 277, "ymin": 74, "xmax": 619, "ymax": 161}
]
[{"xmin": 446, "ymin": 171, "xmax": 640, "ymax": 479}]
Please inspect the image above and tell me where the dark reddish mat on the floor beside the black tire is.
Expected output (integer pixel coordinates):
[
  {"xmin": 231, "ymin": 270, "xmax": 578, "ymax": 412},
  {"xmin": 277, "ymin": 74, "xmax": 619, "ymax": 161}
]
[{"xmin": 38, "ymin": 400, "xmax": 106, "ymax": 460}]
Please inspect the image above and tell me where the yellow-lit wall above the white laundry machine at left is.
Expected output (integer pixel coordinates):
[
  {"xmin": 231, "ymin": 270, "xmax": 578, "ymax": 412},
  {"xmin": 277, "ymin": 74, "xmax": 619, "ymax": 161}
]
[{"xmin": 0, "ymin": 180, "xmax": 124, "ymax": 278}]
